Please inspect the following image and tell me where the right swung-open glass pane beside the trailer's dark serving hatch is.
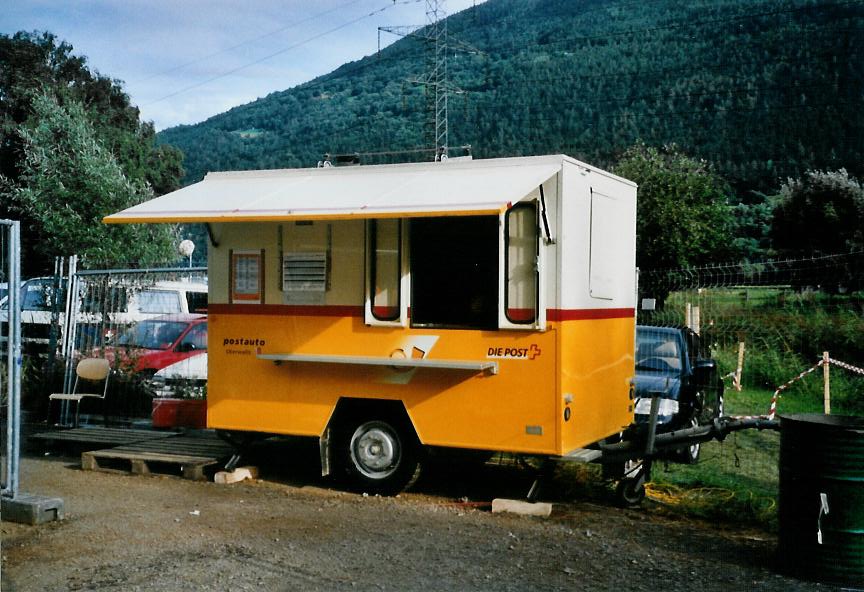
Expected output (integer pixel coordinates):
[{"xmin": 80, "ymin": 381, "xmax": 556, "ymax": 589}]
[{"xmin": 504, "ymin": 203, "xmax": 538, "ymax": 324}]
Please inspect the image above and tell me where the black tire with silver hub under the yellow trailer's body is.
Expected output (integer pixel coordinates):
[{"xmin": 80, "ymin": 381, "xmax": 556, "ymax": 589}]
[{"xmin": 336, "ymin": 417, "xmax": 420, "ymax": 495}]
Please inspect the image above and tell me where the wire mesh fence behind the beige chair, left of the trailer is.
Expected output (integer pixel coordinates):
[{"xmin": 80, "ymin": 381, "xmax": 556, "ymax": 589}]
[{"xmin": 14, "ymin": 258, "xmax": 207, "ymax": 425}]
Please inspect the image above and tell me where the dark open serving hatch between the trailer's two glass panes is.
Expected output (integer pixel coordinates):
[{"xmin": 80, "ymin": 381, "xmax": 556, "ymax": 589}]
[{"xmin": 409, "ymin": 216, "xmax": 498, "ymax": 329}]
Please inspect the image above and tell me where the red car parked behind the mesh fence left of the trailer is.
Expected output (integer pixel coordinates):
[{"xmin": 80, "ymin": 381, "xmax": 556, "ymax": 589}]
[{"xmin": 105, "ymin": 314, "xmax": 207, "ymax": 375}]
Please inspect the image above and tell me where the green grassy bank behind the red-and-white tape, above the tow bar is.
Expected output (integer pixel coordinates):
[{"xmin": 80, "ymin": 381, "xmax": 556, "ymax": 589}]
[{"xmin": 656, "ymin": 288, "xmax": 864, "ymax": 415}]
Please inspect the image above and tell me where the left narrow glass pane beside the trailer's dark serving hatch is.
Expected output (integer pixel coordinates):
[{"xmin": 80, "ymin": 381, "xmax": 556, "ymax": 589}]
[{"xmin": 369, "ymin": 220, "xmax": 402, "ymax": 321}]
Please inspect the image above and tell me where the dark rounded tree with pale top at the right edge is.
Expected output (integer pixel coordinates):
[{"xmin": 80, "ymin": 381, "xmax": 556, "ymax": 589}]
[{"xmin": 771, "ymin": 169, "xmax": 864, "ymax": 256}]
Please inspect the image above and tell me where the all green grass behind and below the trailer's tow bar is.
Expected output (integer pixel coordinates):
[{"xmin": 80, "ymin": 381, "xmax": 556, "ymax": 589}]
[{"xmin": 628, "ymin": 287, "xmax": 864, "ymax": 529}]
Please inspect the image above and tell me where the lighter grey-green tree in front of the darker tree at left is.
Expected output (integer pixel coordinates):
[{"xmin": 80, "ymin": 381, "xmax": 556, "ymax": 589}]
[{"xmin": 0, "ymin": 94, "xmax": 176, "ymax": 269}]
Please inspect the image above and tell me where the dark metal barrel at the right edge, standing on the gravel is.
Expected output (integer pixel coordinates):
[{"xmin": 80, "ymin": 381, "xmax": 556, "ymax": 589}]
[{"xmin": 778, "ymin": 413, "xmax": 864, "ymax": 588}]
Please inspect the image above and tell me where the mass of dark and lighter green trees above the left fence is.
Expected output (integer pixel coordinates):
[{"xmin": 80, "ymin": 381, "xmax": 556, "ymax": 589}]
[{"xmin": 0, "ymin": 32, "xmax": 184, "ymax": 275}]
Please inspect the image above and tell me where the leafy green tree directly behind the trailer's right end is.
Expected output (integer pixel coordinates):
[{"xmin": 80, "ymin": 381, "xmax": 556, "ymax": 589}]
[{"xmin": 613, "ymin": 143, "xmax": 732, "ymax": 269}]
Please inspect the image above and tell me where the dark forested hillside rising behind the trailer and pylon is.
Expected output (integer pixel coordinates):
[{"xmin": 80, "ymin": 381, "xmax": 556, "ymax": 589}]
[{"xmin": 159, "ymin": 0, "xmax": 864, "ymax": 195}]
